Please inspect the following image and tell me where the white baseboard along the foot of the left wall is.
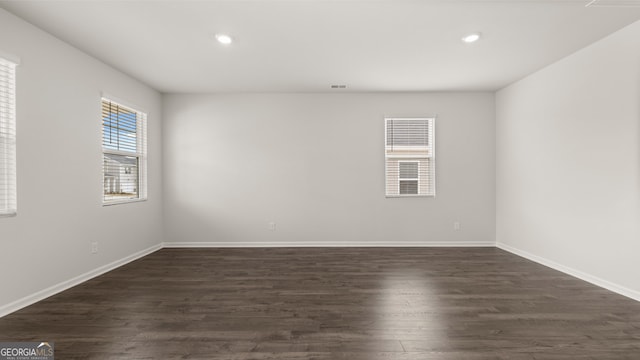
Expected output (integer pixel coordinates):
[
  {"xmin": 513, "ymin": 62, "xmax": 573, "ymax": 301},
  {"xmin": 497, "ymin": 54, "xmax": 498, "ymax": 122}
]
[{"xmin": 0, "ymin": 244, "xmax": 162, "ymax": 318}]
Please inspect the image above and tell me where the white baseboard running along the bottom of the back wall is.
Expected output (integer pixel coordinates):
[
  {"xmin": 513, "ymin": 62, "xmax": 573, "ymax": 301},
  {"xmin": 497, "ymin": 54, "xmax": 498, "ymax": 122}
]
[{"xmin": 163, "ymin": 241, "xmax": 496, "ymax": 248}]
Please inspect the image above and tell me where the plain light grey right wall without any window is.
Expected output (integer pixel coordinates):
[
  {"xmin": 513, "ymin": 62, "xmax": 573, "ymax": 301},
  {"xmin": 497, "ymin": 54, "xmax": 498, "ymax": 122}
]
[{"xmin": 496, "ymin": 22, "xmax": 640, "ymax": 300}]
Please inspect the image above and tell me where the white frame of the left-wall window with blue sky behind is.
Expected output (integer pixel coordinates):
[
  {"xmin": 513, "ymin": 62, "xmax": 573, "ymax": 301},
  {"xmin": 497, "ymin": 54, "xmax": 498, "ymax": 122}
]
[{"xmin": 100, "ymin": 94, "xmax": 148, "ymax": 206}]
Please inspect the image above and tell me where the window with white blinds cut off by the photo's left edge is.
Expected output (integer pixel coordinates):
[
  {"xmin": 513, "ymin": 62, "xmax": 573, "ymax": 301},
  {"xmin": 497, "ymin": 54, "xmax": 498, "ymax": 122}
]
[{"xmin": 0, "ymin": 58, "xmax": 18, "ymax": 216}]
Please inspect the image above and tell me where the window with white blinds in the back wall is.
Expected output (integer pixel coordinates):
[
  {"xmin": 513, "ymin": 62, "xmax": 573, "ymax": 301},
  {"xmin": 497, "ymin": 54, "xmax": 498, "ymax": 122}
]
[{"xmin": 385, "ymin": 118, "xmax": 436, "ymax": 197}]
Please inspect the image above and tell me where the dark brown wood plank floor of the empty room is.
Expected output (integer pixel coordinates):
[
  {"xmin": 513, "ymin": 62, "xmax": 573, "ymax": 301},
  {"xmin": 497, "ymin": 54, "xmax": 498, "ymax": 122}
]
[{"xmin": 0, "ymin": 248, "xmax": 640, "ymax": 360}]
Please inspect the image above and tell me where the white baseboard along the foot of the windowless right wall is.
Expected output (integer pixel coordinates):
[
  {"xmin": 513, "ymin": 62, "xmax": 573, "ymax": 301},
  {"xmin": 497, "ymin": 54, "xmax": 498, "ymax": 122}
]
[{"xmin": 495, "ymin": 242, "xmax": 640, "ymax": 301}]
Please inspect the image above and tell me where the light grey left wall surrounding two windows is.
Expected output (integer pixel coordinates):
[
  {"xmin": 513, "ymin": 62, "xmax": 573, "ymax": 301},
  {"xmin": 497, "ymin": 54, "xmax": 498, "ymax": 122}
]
[{"xmin": 0, "ymin": 9, "xmax": 162, "ymax": 316}]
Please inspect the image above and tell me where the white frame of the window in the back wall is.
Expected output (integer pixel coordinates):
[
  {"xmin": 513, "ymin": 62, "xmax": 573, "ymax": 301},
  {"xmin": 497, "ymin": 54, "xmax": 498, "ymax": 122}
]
[{"xmin": 384, "ymin": 116, "xmax": 436, "ymax": 198}]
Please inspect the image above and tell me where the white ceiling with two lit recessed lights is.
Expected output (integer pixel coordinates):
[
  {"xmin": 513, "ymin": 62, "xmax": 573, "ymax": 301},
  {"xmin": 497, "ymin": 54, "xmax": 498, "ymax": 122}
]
[{"xmin": 0, "ymin": 0, "xmax": 640, "ymax": 93}]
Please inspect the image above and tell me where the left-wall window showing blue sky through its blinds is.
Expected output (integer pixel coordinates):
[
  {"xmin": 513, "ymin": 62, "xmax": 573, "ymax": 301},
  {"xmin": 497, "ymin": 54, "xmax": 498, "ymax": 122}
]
[{"xmin": 102, "ymin": 98, "xmax": 147, "ymax": 205}]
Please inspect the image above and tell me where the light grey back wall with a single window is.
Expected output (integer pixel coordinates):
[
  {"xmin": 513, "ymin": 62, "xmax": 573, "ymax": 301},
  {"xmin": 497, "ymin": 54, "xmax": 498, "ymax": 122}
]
[{"xmin": 163, "ymin": 93, "xmax": 495, "ymax": 245}]
